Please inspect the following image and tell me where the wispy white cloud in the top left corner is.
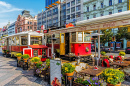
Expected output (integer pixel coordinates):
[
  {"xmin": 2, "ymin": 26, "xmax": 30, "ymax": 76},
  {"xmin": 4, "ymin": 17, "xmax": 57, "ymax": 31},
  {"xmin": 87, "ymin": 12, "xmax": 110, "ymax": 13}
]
[{"xmin": 0, "ymin": 1, "xmax": 22, "ymax": 13}]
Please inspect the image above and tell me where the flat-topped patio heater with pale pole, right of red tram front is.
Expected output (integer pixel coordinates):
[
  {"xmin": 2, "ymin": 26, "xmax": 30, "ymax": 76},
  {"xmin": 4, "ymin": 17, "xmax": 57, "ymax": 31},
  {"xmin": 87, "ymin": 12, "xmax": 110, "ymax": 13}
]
[{"xmin": 88, "ymin": 33, "xmax": 104, "ymax": 66}]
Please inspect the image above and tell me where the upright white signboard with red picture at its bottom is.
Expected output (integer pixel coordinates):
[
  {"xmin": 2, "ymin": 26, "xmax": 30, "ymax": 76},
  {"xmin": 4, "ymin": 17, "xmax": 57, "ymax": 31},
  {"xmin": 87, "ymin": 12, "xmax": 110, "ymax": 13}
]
[{"xmin": 50, "ymin": 59, "xmax": 61, "ymax": 86}]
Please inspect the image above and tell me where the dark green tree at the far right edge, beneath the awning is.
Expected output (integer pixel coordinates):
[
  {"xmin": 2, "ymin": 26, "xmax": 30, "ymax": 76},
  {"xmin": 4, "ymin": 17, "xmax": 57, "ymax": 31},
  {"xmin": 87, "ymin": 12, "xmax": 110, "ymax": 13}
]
[{"xmin": 116, "ymin": 27, "xmax": 130, "ymax": 42}]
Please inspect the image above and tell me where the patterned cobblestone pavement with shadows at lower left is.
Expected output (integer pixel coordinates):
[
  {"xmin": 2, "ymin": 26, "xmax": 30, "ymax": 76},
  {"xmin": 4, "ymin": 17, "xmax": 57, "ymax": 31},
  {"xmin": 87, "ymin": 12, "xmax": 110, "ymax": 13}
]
[{"xmin": 0, "ymin": 53, "xmax": 48, "ymax": 86}]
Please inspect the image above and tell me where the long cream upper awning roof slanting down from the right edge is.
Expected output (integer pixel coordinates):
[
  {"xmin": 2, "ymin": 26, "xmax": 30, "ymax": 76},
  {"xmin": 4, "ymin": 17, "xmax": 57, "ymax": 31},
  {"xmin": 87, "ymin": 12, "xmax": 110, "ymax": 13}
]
[{"xmin": 76, "ymin": 11, "xmax": 130, "ymax": 26}]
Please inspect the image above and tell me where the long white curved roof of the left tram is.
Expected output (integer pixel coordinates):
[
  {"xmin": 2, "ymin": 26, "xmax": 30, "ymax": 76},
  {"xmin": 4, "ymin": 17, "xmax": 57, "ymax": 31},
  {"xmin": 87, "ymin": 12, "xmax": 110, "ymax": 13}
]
[{"xmin": 3, "ymin": 31, "xmax": 43, "ymax": 38}]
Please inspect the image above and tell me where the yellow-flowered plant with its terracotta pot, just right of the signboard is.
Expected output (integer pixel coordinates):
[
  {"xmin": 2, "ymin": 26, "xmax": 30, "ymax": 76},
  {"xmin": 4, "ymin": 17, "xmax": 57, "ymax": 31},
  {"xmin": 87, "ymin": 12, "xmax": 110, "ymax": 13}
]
[{"xmin": 61, "ymin": 63, "xmax": 75, "ymax": 76}]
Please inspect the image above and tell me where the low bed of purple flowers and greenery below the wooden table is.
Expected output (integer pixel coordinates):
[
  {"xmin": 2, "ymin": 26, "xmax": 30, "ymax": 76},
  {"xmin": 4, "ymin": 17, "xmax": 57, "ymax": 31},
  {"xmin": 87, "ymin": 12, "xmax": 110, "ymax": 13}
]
[{"xmin": 74, "ymin": 77, "xmax": 103, "ymax": 86}]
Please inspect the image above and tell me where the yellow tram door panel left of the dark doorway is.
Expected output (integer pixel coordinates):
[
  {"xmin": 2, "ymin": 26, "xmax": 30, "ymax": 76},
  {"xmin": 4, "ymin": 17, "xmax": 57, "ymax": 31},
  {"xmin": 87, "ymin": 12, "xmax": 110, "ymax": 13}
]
[{"xmin": 60, "ymin": 33, "xmax": 65, "ymax": 55}]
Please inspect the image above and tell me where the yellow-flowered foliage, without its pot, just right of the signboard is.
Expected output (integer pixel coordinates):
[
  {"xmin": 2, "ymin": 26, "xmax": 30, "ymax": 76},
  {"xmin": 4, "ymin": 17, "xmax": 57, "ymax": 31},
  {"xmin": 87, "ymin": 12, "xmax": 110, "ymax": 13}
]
[{"xmin": 61, "ymin": 63, "xmax": 75, "ymax": 73}]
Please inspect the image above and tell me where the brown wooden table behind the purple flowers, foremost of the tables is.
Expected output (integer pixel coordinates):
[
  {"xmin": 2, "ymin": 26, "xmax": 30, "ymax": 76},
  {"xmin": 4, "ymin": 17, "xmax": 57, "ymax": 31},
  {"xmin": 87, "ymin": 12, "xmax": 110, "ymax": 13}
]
[{"xmin": 80, "ymin": 67, "xmax": 105, "ymax": 76}]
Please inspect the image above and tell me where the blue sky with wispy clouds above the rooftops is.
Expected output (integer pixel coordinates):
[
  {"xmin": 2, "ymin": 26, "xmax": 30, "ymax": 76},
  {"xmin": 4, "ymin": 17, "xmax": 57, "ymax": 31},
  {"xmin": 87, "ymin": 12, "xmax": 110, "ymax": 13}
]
[{"xmin": 0, "ymin": 0, "xmax": 45, "ymax": 28}]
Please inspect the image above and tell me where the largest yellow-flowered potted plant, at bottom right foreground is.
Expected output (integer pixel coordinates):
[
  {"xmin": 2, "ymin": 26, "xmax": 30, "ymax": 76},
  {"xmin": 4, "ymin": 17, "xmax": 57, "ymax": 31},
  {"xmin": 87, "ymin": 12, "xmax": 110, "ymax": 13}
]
[{"xmin": 102, "ymin": 68, "xmax": 125, "ymax": 86}]
